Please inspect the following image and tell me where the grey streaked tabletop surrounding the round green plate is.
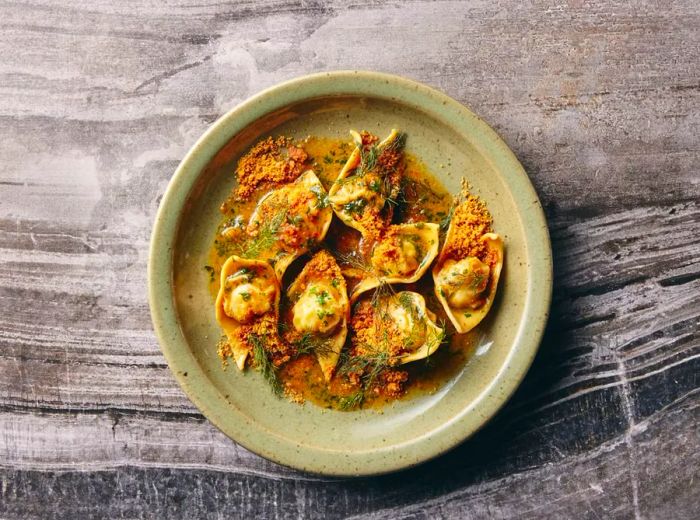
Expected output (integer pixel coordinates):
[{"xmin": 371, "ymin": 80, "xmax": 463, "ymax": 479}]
[{"xmin": 0, "ymin": 0, "xmax": 700, "ymax": 519}]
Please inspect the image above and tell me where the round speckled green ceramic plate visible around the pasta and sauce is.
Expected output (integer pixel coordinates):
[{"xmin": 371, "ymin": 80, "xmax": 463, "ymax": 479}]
[{"xmin": 148, "ymin": 71, "xmax": 552, "ymax": 475}]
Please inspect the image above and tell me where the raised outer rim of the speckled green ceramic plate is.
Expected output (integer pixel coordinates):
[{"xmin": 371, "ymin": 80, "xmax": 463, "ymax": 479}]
[{"xmin": 148, "ymin": 70, "xmax": 553, "ymax": 476}]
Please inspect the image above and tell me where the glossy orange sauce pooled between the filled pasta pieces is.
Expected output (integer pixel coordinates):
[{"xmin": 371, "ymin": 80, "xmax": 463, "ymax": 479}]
[{"xmin": 206, "ymin": 137, "xmax": 476, "ymax": 409}]
